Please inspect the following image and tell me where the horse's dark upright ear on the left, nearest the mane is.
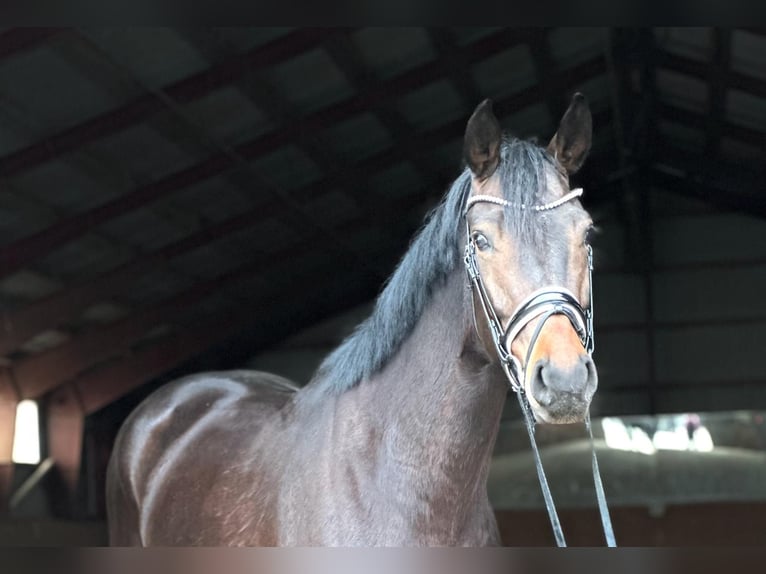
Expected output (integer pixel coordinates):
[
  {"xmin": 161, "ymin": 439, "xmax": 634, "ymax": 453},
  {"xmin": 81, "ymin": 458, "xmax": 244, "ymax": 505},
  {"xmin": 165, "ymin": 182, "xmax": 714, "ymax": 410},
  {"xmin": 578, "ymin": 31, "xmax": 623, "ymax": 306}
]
[{"xmin": 463, "ymin": 100, "xmax": 503, "ymax": 179}]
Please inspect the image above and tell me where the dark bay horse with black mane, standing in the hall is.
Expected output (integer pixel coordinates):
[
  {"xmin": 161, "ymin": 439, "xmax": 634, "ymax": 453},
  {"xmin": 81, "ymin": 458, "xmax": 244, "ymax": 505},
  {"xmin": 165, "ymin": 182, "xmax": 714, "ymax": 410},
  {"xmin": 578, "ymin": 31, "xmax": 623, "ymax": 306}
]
[{"xmin": 107, "ymin": 94, "xmax": 597, "ymax": 546}]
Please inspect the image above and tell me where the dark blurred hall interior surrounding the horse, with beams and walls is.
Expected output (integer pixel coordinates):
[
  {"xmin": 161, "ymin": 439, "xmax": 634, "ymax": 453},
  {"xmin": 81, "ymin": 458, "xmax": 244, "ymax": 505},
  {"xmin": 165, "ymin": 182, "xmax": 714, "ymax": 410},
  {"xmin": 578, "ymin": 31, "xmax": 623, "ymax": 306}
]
[{"xmin": 0, "ymin": 27, "xmax": 766, "ymax": 546}]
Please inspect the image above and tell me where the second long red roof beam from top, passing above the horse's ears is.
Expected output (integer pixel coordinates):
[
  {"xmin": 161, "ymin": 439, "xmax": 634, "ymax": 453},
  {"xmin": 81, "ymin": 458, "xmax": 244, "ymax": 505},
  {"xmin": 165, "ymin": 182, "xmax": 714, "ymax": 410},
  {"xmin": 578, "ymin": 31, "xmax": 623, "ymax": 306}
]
[{"xmin": 0, "ymin": 31, "xmax": 529, "ymax": 277}]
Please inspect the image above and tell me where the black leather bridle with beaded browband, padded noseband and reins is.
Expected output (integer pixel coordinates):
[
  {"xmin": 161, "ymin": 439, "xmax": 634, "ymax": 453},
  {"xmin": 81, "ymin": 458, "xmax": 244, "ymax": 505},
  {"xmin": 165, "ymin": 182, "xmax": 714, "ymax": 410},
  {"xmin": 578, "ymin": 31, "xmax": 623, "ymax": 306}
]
[{"xmin": 464, "ymin": 188, "xmax": 617, "ymax": 547}]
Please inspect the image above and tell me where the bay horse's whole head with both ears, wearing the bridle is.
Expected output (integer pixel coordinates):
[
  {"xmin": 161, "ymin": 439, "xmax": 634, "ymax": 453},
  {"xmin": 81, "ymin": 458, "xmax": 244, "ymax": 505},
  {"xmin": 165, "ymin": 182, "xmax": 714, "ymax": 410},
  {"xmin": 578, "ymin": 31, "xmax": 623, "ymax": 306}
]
[{"xmin": 464, "ymin": 94, "xmax": 598, "ymax": 423}]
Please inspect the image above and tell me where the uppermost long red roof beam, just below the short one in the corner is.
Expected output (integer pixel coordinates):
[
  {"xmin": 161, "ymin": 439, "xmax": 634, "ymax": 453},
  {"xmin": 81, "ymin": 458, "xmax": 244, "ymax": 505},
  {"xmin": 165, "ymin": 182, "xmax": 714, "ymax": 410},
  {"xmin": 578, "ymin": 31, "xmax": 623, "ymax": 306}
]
[{"xmin": 0, "ymin": 28, "xmax": 338, "ymax": 177}]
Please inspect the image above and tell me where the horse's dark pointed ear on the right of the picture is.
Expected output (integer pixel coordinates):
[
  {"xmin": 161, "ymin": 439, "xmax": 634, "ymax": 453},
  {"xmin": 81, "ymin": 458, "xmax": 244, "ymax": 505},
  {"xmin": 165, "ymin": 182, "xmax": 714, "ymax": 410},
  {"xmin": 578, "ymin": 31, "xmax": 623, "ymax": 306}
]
[{"xmin": 548, "ymin": 92, "xmax": 593, "ymax": 175}]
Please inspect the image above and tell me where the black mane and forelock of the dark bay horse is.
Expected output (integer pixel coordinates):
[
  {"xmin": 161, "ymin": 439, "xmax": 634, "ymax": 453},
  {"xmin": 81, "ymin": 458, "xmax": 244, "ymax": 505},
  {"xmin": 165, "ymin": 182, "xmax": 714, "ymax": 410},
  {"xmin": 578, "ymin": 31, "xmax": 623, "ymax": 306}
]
[{"xmin": 313, "ymin": 139, "xmax": 553, "ymax": 393}]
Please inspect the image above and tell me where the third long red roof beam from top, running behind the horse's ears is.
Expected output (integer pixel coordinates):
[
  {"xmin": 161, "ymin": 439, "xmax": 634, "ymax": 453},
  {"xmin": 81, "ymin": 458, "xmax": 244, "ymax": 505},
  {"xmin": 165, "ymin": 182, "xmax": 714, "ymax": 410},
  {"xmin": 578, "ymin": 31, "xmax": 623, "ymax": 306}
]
[{"xmin": 0, "ymin": 51, "xmax": 605, "ymax": 355}]
